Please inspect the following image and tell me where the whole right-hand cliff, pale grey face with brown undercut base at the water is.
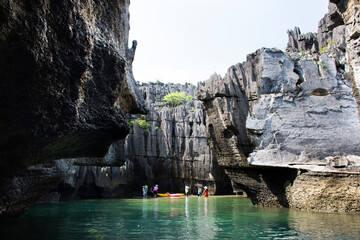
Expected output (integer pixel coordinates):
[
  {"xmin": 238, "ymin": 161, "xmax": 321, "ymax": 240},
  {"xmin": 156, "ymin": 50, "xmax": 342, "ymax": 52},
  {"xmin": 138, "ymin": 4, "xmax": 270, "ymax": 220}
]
[{"xmin": 197, "ymin": 1, "xmax": 360, "ymax": 212}]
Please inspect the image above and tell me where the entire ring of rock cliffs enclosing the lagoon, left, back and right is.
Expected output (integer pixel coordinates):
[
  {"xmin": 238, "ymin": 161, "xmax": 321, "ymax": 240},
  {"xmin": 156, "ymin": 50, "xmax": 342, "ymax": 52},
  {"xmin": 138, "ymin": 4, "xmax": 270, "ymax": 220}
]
[{"xmin": 0, "ymin": 0, "xmax": 360, "ymax": 216}]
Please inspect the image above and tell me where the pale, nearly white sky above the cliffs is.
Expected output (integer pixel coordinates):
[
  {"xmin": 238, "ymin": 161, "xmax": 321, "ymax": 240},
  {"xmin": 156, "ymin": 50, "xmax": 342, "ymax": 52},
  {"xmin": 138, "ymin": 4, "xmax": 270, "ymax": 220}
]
[{"xmin": 129, "ymin": 0, "xmax": 328, "ymax": 83}]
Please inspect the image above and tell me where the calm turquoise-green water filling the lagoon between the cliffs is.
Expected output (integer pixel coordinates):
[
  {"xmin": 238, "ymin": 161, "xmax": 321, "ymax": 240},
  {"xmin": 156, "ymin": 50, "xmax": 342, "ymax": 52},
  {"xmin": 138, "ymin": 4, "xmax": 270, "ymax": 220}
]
[{"xmin": 0, "ymin": 196, "xmax": 360, "ymax": 240}]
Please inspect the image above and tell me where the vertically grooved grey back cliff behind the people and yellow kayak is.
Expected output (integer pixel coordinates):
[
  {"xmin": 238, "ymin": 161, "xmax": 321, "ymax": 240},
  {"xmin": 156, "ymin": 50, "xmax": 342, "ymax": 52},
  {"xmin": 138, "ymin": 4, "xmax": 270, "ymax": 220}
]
[{"xmin": 50, "ymin": 82, "xmax": 232, "ymax": 199}]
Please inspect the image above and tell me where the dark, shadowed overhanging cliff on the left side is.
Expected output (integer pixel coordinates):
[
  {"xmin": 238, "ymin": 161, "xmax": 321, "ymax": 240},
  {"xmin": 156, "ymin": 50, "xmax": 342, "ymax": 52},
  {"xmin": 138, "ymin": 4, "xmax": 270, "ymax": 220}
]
[{"xmin": 0, "ymin": 0, "xmax": 145, "ymax": 218}]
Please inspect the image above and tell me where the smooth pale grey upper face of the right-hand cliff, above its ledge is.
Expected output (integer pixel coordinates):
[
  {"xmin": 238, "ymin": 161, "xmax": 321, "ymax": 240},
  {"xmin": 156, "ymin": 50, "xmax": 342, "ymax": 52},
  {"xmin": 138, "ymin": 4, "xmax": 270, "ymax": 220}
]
[{"xmin": 246, "ymin": 52, "xmax": 360, "ymax": 169}]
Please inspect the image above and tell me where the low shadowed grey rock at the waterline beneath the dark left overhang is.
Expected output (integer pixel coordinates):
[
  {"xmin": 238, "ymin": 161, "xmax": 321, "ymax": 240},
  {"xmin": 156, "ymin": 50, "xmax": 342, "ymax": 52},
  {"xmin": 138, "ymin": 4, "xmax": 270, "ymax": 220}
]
[{"xmin": 50, "ymin": 158, "xmax": 133, "ymax": 200}]
